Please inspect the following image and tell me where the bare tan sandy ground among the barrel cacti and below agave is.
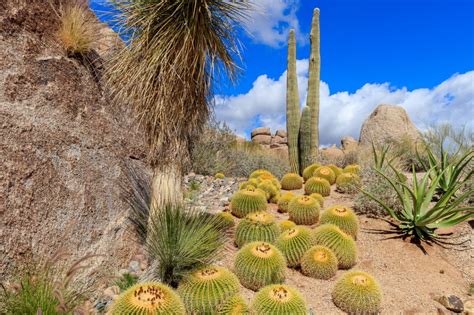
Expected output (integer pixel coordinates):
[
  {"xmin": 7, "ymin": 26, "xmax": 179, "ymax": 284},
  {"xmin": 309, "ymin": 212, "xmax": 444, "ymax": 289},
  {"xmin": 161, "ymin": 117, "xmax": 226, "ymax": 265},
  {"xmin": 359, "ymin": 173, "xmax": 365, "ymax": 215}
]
[{"xmin": 221, "ymin": 188, "xmax": 474, "ymax": 314}]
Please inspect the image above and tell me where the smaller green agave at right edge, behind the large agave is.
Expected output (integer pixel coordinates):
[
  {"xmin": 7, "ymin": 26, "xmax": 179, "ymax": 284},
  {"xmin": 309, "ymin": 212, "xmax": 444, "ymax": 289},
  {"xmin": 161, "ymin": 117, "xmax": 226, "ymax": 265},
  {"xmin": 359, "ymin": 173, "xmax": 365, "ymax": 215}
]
[{"xmin": 417, "ymin": 145, "xmax": 474, "ymax": 196}]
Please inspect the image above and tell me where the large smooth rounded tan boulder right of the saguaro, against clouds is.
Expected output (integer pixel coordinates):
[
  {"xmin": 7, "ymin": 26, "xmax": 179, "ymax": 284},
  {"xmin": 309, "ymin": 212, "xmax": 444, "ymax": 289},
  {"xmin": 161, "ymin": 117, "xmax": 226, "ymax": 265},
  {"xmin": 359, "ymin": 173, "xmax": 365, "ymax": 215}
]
[{"xmin": 359, "ymin": 104, "xmax": 420, "ymax": 145}]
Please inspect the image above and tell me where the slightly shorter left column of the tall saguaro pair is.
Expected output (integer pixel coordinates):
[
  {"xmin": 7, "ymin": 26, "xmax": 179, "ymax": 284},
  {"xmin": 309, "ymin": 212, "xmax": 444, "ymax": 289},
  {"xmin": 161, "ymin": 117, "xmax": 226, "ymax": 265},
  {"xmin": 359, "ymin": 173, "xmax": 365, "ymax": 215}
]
[{"xmin": 286, "ymin": 29, "xmax": 300, "ymax": 173}]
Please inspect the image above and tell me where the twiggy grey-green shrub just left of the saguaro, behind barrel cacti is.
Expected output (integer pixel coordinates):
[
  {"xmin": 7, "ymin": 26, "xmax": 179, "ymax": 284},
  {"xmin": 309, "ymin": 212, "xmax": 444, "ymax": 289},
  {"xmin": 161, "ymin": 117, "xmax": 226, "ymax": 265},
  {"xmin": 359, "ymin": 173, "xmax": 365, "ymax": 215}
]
[{"xmin": 190, "ymin": 121, "xmax": 289, "ymax": 178}]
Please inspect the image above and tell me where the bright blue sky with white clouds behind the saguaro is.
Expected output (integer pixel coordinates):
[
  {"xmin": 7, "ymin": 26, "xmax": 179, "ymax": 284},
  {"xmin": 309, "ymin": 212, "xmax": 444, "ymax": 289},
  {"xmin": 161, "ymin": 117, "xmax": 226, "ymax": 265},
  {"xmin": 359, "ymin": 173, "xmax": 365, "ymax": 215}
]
[{"xmin": 91, "ymin": 0, "xmax": 474, "ymax": 144}]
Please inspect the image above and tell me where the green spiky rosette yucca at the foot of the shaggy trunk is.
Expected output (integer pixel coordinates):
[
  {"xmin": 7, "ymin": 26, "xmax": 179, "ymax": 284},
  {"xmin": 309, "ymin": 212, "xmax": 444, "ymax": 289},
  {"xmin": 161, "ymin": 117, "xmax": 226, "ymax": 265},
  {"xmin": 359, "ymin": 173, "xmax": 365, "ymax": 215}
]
[{"xmin": 145, "ymin": 205, "xmax": 230, "ymax": 287}]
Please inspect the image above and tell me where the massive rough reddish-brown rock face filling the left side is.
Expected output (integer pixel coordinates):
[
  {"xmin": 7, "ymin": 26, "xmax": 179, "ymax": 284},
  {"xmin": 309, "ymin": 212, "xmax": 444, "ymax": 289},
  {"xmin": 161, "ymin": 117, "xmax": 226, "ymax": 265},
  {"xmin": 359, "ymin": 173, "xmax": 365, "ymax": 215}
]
[{"xmin": 0, "ymin": 0, "xmax": 145, "ymax": 282}]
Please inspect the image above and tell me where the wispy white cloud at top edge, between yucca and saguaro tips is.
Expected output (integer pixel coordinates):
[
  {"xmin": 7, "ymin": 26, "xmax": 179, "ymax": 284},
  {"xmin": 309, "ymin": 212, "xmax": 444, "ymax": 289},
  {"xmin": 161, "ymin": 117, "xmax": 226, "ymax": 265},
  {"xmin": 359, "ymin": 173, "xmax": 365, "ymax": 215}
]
[{"xmin": 241, "ymin": 0, "xmax": 304, "ymax": 47}]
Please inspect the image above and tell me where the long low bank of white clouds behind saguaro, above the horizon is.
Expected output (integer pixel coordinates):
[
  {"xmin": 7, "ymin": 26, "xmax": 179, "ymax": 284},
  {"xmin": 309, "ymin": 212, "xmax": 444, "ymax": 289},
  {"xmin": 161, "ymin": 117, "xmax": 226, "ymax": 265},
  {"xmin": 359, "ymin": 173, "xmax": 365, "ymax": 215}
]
[{"xmin": 215, "ymin": 67, "xmax": 474, "ymax": 145}]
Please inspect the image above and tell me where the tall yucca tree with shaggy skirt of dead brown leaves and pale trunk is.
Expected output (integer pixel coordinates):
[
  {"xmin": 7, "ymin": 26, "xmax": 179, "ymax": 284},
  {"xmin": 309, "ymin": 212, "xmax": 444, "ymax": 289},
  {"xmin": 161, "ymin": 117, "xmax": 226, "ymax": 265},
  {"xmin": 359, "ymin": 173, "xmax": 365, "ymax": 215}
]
[{"xmin": 109, "ymin": 0, "xmax": 249, "ymax": 216}]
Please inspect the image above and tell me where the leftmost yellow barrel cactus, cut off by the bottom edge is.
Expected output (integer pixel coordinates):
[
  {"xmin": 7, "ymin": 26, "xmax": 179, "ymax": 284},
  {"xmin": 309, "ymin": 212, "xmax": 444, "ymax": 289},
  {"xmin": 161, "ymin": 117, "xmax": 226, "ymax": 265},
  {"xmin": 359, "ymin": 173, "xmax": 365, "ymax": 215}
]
[{"xmin": 110, "ymin": 282, "xmax": 185, "ymax": 315}]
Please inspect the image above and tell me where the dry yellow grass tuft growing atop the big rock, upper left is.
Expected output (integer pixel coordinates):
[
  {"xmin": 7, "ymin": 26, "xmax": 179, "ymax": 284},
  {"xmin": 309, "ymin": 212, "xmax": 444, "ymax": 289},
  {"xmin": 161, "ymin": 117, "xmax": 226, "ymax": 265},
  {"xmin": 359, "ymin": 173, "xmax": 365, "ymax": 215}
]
[{"xmin": 56, "ymin": 0, "xmax": 100, "ymax": 55}]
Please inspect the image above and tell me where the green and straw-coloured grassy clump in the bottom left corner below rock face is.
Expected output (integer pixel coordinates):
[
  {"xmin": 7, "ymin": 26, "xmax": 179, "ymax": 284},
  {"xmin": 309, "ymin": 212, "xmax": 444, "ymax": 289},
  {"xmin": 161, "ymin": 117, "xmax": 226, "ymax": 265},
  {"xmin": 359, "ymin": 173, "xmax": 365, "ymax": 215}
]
[{"xmin": 0, "ymin": 253, "xmax": 92, "ymax": 315}]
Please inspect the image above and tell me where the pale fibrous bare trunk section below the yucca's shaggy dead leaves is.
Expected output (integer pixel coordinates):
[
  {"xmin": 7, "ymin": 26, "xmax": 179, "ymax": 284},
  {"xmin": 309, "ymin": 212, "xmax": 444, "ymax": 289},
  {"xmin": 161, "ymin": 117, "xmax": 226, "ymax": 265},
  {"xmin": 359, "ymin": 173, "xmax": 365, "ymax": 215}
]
[{"xmin": 150, "ymin": 165, "xmax": 183, "ymax": 216}]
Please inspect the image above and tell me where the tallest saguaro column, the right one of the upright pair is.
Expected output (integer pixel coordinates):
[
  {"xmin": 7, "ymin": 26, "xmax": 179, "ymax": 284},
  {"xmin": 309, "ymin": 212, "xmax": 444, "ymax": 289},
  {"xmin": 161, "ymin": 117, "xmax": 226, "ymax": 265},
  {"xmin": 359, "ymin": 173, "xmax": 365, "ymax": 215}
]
[{"xmin": 307, "ymin": 8, "xmax": 321, "ymax": 159}]
